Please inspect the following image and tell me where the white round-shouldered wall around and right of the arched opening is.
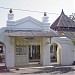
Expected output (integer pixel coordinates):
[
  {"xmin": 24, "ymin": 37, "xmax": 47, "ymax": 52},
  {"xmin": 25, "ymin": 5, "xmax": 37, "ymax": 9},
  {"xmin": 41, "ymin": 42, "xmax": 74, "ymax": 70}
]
[{"xmin": 51, "ymin": 37, "xmax": 74, "ymax": 65}]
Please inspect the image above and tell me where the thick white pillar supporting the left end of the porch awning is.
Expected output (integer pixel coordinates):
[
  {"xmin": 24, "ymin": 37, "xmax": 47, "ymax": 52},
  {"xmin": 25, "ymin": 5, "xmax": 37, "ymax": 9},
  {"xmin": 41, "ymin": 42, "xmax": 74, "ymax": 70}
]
[{"xmin": 5, "ymin": 36, "xmax": 15, "ymax": 68}]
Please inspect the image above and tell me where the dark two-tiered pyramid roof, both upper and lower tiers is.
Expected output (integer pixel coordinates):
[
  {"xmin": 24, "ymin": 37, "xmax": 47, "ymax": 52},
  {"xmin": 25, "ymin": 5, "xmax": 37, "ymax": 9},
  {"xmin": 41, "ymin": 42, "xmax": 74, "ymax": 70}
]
[{"xmin": 51, "ymin": 10, "xmax": 75, "ymax": 40}]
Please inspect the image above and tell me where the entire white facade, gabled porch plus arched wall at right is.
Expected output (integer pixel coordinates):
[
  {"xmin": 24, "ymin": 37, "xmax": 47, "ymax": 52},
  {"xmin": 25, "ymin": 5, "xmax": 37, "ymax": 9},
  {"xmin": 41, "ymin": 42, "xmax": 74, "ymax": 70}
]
[{"xmin": 0, "ymin": 9, "xmax": 74, "ymax": 68}]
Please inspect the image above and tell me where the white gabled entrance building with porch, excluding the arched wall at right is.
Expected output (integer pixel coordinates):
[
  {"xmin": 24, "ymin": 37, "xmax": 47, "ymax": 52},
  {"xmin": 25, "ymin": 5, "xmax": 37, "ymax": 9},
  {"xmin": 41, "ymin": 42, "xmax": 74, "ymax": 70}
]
[{"xmin": 0, "ymin": 9, "xmax": 58, "ymax": 68}]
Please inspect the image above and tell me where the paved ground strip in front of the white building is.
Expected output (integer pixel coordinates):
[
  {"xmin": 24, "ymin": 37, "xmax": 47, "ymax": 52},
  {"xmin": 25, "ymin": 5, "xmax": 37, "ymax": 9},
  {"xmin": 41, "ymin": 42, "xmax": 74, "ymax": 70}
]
[{"xmin": 0, "ymin": 65, "xmax": 75, "ymax": 75}]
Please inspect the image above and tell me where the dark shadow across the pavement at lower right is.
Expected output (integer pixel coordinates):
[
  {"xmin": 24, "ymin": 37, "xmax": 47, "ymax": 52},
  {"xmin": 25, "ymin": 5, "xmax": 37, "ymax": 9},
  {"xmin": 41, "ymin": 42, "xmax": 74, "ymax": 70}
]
[{"xmin": 21, "ymin": 66, "xmax": 75, "ymax": 74}]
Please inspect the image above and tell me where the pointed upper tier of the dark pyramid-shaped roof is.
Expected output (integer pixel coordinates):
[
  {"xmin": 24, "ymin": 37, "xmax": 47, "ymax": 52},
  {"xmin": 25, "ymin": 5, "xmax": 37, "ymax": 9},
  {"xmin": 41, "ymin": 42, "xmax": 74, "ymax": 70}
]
[{"xmin": 50, "ymin": 10, "xmax": 75, "ymax": 29}]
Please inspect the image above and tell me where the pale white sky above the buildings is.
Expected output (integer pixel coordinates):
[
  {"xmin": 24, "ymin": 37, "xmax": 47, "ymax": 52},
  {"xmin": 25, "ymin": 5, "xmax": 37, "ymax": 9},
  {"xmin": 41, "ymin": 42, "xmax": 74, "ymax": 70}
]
[{"xmin": 0, "ymin": 0, "xmax": 75, "ymax": 28}]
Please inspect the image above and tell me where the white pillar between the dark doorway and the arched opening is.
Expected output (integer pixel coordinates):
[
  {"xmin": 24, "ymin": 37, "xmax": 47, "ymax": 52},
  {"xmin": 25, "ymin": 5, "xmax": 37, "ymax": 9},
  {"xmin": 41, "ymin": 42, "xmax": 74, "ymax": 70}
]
[{"xmin": 43, "ymin": 38, "xmax": 50, "ymax": 65}]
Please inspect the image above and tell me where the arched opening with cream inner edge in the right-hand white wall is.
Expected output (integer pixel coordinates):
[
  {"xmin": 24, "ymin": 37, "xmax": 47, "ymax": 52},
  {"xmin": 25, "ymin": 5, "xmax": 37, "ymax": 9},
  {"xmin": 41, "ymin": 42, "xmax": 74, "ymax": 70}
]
[{"xmin": 50, "ymin": 42, "xmax": 61, "ymax": 64}]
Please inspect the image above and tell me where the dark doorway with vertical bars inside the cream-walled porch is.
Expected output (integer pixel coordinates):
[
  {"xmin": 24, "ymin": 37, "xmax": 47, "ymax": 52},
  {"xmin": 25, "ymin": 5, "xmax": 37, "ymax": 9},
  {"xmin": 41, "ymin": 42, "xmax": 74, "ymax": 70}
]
[{"xmin": 29, "ymin": 45, "xmax": 40, "ymax": 62}]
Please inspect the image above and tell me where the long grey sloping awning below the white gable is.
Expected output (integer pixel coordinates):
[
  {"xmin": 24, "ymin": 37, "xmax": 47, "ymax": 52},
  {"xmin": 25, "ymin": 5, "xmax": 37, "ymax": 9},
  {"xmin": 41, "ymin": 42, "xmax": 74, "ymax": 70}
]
[{"xmin": 5, "ymin": 28, "xmax": 58, "ymax": 37}]
